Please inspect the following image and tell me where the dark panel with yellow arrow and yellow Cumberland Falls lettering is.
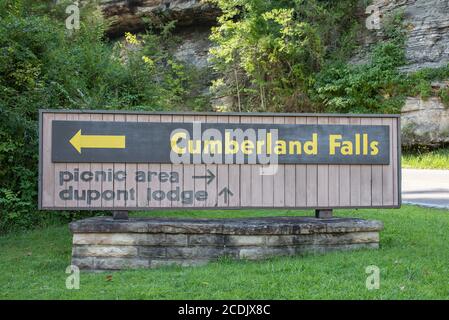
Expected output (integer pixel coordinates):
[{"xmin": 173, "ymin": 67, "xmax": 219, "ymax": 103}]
[{"xmin": 52, "ymin": 120, "xmax": 390, "ymax": 164}]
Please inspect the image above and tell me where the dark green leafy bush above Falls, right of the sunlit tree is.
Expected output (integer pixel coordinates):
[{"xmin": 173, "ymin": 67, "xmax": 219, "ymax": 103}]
[{"xmin": 311, "ymin": 42, "xmax": 404, "ymax": 113}]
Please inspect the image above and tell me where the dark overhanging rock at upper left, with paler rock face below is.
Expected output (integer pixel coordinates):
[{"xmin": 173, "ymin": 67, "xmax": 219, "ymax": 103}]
[{"xmin": 100, "ymin": 0, "xmax": 220, "ymax": 101}]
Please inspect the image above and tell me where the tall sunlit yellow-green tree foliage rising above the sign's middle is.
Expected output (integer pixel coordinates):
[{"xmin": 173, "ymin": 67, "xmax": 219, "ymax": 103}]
[{"xmin": 211, "ymin": 0, "xmax": 364, "ymax": 111}]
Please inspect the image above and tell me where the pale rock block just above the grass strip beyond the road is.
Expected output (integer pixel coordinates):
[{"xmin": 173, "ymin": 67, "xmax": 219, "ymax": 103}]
[{"xmin": 401, "ymin": 97, "xmax": 449, "ymax": 146}]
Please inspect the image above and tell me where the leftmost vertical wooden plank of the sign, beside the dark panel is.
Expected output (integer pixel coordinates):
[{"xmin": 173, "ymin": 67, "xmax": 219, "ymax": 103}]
[{"xmin": 42, "ymin": 113, "xmax": 55, "ymax": 207}]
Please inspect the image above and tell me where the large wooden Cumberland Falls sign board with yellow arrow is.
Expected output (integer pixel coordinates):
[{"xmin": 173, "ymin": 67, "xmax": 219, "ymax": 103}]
[{"xmin": 39, "ymin": 110, "xmax": 401, "ymax": 210}]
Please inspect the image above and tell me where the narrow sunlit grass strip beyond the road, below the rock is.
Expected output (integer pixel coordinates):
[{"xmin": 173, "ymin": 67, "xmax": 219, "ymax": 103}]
[{"xmin": 402, "ymin": 149, "xmax": 449, "ymax": 169}]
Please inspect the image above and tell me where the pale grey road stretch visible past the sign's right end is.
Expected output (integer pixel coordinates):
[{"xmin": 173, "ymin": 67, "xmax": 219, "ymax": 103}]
[{"xmin": 402, "ymin": 169, "xmax": 449, "ymax": 209}]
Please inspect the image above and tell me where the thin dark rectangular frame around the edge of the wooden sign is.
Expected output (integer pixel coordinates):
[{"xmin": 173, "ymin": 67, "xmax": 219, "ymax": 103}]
[{"xmin": 38, "ymin": 109, "xmax": 402, "ymax": 211}]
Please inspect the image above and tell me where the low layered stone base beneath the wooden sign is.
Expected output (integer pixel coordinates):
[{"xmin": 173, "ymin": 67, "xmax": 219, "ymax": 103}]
[{"xmin": 70, "ymin": 217, "xmax": 383, "ymax": 270}]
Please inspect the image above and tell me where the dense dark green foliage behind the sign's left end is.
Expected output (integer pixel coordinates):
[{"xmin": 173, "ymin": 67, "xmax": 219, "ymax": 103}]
[{"xmin": 0, "ymin": 0, "xmax": 198, "ymax": 232}]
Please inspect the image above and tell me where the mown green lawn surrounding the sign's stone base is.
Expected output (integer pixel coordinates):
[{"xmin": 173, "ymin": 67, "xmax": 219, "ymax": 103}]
[{"xmin": 0, "ymin": 206, "xmax": 449, "ymax": 299}]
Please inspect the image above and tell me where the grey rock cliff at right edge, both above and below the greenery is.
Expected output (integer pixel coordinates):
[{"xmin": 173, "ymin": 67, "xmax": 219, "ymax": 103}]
[{"xmin": 364, "ymin": 0, "xmax": 449, "ymax": 146}]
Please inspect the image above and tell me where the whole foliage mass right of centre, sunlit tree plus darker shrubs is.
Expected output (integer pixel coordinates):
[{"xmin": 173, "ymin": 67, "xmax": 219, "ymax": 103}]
[{"xmin": 211, "ymin": 0, "xmax": 449, "ymax": 113}]
